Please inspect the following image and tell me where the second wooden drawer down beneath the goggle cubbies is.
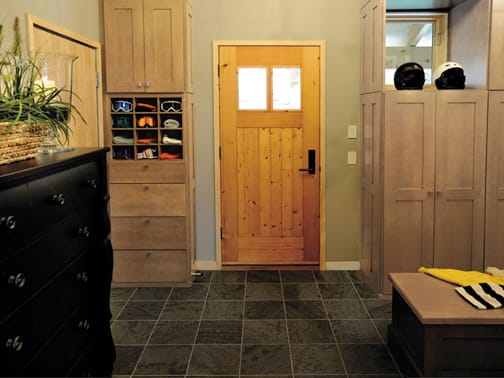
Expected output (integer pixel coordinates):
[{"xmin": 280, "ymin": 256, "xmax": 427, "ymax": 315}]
[{"xmin": 110, "ymin": 184, "xmax": 186, "ymax": 217}]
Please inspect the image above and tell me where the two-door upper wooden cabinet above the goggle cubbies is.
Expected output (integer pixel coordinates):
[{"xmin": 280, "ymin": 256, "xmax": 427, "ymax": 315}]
[{"xmin": 103, "ymin": 0, "xmax": 192, "ymax": 93}]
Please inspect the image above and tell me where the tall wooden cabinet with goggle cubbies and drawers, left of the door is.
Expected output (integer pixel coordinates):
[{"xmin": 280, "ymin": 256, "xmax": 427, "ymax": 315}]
[{"xmin": 102, "ymin": 0, "xmax": 194, "ymax": 286}]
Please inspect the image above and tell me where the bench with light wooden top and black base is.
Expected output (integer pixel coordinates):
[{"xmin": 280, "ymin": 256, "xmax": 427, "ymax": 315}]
[{"xmin": 388, "ymin": 273, "xmax": 504, "ymax": 377}]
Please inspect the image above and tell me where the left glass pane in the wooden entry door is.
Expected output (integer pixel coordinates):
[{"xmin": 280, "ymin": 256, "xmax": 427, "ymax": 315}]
[{"xmin": 238, "ymin": 67, "xmax": 267, "ymax": 110}]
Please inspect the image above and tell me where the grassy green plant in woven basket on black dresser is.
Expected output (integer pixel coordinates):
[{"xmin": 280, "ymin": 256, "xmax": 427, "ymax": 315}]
[{"xmin": 0, "ymin": 17, "xmax": 85, "ymax": 164}]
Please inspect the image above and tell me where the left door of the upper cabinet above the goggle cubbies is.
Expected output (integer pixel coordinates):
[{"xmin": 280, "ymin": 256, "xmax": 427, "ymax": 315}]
[{"xmin": 103, "ymin": 0, "xmax": 145, "ymax": 92}]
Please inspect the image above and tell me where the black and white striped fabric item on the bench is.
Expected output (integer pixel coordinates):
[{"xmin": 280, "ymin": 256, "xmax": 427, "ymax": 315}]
[{"xmin": 455, "ymin": 283, "xmax": 504, "ymax": 310}]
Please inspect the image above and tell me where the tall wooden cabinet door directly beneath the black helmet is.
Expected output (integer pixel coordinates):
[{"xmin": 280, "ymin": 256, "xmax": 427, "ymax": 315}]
[{"xmin": 383, "ymin": 91, "xmax": 436, "ymax": 293}]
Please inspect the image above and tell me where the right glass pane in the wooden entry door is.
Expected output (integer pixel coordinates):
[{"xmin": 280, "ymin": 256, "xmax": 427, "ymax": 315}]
[{"xmin": 272, "ymin": 67, "xmax": 301, "ymax": 110}]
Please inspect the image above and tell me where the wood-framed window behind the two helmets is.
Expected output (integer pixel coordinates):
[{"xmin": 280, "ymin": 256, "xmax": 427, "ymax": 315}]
[{"xmin": 385, "ymin": 13, "xmax": 448, "ymax": 88}]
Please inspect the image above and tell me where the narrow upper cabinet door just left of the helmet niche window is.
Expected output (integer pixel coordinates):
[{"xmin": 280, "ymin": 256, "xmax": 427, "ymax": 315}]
[{"xmin": 361, "ymin": 0, "xmax": 385, "ymax": 93}]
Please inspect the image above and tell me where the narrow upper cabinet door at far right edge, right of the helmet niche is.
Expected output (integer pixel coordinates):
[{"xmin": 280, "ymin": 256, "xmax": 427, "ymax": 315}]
[{"xmin": 488, "ymin": 0, "xmax": 504, "ymax": 90}]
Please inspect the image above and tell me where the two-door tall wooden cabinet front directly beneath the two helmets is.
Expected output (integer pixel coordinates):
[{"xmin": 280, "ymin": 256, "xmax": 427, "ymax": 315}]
[{"xmin": 382, "ymin": 90, "xmax": 487, "ymax": 293}]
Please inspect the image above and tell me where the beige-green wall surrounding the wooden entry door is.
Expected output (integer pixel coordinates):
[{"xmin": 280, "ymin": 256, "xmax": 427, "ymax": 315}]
[{"xmin": 191, "ymin": 0, "xmax": 360, "ymax": 262}]
